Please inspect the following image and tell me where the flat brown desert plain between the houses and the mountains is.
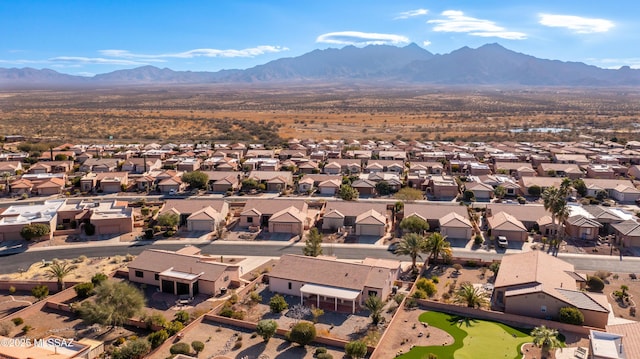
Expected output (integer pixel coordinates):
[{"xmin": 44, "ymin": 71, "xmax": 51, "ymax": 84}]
[{"xmin": 0, "ymin": 83, "xmax": 640, "ymax": 146}]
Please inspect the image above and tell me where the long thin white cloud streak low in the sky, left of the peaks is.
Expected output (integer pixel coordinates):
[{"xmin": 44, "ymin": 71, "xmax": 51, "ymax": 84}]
[{"xmin": 100, "ymin": 45, "xmax": 289, "ymax": 61}]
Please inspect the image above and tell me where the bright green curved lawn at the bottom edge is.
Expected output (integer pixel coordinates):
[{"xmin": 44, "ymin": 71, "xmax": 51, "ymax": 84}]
[{"xmin": 399, "ymin": 312, "xmax": 533, "ymax": 359}]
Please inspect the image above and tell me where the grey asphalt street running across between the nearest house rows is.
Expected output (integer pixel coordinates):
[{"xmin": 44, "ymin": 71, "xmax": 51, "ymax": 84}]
[{"xmin": 0, "ymin": 241, "xmax": 640, "ymax": 274}]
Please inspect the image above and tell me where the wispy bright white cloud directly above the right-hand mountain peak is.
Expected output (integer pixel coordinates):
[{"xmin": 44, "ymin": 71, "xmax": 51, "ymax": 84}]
[{"xmin": 427, "ymin": 10, "xmax": 527, "ymax": 40}]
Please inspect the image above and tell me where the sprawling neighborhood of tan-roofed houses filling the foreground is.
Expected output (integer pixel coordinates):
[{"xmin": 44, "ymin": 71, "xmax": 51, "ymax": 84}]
[{"xmin": 0, "ymin": 136, "xmax": 640, "ymax": 358}]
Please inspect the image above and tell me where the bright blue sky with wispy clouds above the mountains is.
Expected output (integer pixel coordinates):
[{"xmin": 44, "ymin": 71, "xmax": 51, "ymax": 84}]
[{"xmin": 0, "ymin": 0, "xmax": 640, "ymax": 76}]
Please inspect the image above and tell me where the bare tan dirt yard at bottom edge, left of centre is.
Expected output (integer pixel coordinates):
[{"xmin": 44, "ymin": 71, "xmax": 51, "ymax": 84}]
[{"xmin": 150, "ymin": 321, "xmax": 344, "ymax": 359}]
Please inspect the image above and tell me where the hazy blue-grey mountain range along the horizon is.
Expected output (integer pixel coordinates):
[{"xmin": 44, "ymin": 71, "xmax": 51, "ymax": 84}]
[{"xmin": 0, "ymin": 44, "xmax": 640, "ymax": 88}]
